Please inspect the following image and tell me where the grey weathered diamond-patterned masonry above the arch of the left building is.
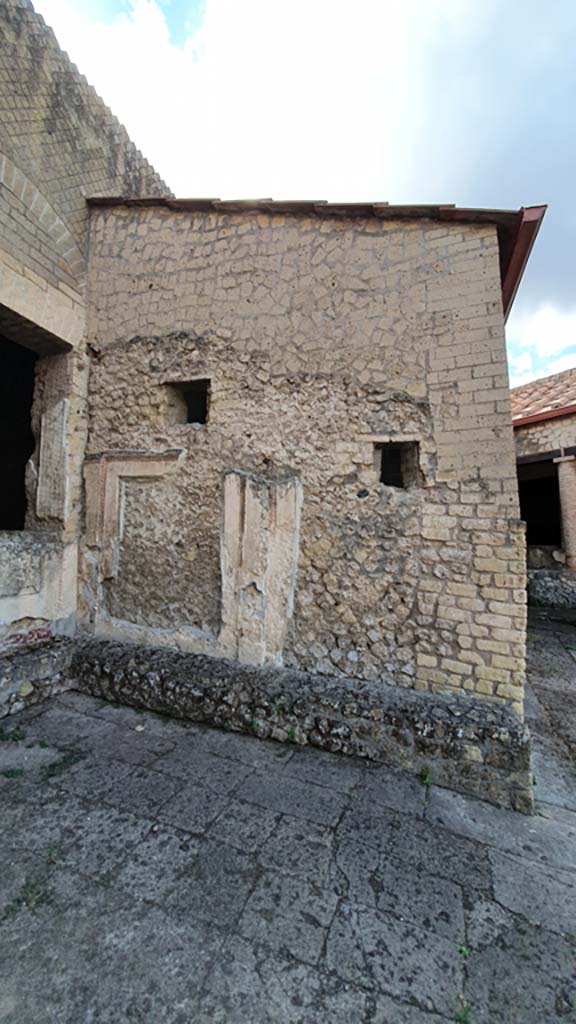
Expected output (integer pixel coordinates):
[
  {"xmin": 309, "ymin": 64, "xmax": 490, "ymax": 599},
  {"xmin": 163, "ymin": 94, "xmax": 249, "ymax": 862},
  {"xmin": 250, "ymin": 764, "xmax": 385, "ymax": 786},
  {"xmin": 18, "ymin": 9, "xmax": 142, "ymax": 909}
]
[{"xmin": 0, "ymin": 0, "xmax": 168, "ymax": 295}]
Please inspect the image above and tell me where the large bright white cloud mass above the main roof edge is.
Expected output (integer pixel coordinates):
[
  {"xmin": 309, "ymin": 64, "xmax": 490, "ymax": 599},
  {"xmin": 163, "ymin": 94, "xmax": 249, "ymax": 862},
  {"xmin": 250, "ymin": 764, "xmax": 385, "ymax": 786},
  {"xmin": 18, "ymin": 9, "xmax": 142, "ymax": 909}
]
[{"xmin": 36, "ymin": 0, "xmax": 475, "ymax": 201}]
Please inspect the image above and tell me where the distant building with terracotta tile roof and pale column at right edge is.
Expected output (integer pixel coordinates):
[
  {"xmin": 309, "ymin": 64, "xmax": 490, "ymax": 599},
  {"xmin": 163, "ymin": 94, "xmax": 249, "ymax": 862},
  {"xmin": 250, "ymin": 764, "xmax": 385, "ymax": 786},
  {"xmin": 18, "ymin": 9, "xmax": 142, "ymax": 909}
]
[{"xmin": 511, "ymin": 368, "xmax": 576, "ymax": 606}]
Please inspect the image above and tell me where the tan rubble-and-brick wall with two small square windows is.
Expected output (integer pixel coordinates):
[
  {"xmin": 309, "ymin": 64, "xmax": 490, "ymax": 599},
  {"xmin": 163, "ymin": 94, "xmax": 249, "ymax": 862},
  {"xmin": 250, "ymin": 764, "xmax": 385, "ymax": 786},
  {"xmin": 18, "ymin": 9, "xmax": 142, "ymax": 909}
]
[{"xmin": 81, "ymin": 207, "xmax": 525, "ymax": 710}]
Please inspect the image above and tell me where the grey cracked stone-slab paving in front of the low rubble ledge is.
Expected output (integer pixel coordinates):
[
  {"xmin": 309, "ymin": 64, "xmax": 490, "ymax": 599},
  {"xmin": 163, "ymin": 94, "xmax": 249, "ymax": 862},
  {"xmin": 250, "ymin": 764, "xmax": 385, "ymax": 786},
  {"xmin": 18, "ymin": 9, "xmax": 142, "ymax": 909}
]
[{"xmin": 0, "ymin": 618, "xmax": 576, "ymax": 1024}]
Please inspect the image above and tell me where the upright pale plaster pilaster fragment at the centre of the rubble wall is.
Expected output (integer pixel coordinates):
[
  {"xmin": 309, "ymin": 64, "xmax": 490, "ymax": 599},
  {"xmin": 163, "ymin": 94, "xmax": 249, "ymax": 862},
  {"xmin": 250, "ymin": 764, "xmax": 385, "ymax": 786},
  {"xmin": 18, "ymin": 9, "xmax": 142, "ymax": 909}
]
[{"xmin": 219, "ymin": 471, "xmax": 301, "ymax": 665}]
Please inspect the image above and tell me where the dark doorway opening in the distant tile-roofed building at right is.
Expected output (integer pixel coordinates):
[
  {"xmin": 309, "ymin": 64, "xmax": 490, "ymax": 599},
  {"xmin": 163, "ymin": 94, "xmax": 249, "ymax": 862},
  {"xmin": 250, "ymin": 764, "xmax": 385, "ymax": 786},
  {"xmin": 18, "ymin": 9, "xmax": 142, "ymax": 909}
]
[{"xmin": 518, "ymin": 462, "xmax": 562, "ymax": 548}]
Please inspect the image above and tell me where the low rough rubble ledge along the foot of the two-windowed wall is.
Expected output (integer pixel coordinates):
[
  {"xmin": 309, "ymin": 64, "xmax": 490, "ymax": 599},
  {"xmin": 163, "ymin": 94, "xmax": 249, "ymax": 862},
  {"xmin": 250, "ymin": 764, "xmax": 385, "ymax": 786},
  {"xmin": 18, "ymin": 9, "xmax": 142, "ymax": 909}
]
[{"xmin": 70, "ymin": 639, "xmax": 533, "ymax": 814}]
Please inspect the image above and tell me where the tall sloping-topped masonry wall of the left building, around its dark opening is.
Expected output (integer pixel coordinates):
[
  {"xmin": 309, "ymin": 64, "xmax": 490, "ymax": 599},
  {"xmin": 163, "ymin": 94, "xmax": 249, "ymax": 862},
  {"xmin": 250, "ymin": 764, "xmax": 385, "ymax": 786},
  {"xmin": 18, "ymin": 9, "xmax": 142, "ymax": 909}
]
[{"xmin": 0, "ymin": 0, "xmax": 167, "ymax": 644}]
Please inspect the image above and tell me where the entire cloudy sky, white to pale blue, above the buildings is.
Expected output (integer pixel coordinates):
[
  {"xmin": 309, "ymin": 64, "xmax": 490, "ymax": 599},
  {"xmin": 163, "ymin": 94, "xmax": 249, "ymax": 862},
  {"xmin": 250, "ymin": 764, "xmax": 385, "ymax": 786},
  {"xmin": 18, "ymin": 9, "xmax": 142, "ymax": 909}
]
[{"xmin": 34, "ymin": 0, "xmax": 576, "ymax": 383}]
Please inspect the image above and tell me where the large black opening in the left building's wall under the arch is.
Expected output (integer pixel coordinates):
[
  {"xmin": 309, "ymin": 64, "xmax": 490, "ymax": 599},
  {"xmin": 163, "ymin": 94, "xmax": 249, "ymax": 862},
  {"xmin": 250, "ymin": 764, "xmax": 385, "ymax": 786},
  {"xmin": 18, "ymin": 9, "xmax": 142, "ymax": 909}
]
[{"xmin": 0, "ymin": 337, "xmax": 37, "ymax": 529}]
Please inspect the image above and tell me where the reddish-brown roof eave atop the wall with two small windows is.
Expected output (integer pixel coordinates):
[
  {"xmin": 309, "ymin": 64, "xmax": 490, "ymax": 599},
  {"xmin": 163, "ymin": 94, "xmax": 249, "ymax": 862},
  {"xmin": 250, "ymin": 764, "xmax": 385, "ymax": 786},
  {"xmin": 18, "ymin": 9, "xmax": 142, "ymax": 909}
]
[{"xmin": 86, "ymin": 196, "xmax": 546, "ymax": 318}]
